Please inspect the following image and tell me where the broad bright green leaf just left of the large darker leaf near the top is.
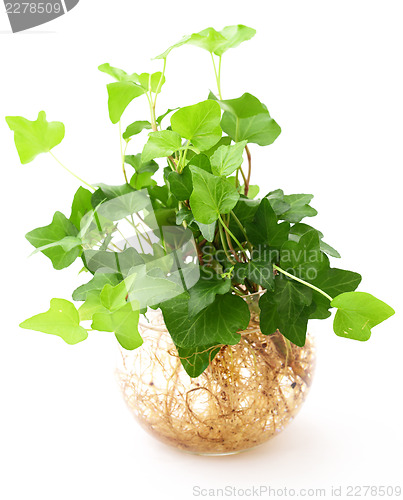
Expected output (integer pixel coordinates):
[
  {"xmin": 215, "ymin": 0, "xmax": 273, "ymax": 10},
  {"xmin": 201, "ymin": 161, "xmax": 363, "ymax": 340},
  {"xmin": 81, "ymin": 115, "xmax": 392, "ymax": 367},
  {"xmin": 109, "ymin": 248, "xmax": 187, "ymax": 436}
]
[{"xmin": 171, "ymin": 100, "xmax": 222, "ymax": 151}]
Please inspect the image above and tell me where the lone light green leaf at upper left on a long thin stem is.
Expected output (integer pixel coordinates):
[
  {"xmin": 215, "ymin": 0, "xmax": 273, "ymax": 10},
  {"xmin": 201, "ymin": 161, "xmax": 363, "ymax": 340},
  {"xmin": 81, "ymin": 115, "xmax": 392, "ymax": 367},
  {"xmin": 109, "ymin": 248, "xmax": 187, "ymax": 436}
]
[{"xmin": 6, "ymin": 111, "xmax": 65, "ymax": 165}]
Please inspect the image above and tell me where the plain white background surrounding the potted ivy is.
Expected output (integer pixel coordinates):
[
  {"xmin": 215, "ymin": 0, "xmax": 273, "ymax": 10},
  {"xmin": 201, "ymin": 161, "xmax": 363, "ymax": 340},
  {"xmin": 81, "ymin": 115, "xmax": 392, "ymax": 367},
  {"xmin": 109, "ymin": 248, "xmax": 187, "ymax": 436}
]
[{"xmin": 0, "ymin": 0, "xmax": 403, "ymax": 500}]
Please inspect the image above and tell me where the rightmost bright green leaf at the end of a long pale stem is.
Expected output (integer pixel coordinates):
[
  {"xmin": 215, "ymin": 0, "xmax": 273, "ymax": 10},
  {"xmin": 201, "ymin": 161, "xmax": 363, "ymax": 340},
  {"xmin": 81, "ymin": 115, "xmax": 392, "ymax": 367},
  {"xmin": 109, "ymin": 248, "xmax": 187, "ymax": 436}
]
[{"xmin": 331, "ymin": 292, "xmax": 395, "ymax": 341}]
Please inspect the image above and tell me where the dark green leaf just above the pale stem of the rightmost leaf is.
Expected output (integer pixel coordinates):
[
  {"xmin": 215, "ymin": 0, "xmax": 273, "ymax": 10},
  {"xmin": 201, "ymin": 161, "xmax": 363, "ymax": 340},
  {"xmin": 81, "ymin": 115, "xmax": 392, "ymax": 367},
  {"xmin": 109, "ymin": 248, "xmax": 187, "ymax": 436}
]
[{"xmin": 280, "ymin": 230, "xmax": 329, "ymax": 282}]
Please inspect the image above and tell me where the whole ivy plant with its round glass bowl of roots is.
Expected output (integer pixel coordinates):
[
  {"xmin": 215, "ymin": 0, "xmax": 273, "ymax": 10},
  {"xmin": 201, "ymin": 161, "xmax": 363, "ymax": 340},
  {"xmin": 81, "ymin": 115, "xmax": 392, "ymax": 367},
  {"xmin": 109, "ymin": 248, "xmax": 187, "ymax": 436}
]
[{"xmin": 6, "ymin": 25, "xmax": 394, "ymax": 454}]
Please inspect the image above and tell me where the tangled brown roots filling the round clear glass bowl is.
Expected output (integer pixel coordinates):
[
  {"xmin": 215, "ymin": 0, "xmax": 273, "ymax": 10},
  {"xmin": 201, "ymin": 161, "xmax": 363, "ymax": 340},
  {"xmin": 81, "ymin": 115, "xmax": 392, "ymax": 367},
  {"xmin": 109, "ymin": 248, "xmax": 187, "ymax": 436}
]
[{"xmin": 118, "ymin": 313, "xmax": 315, "ymax": 455}]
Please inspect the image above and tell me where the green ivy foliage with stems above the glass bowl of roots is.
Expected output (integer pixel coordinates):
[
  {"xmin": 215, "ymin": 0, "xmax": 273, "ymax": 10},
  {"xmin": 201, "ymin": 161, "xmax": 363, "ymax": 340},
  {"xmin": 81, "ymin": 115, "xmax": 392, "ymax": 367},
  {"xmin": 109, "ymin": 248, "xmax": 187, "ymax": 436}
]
[{"xmin": 6, "ymin": 25, "xmax": 394, "ymax": 377}]
